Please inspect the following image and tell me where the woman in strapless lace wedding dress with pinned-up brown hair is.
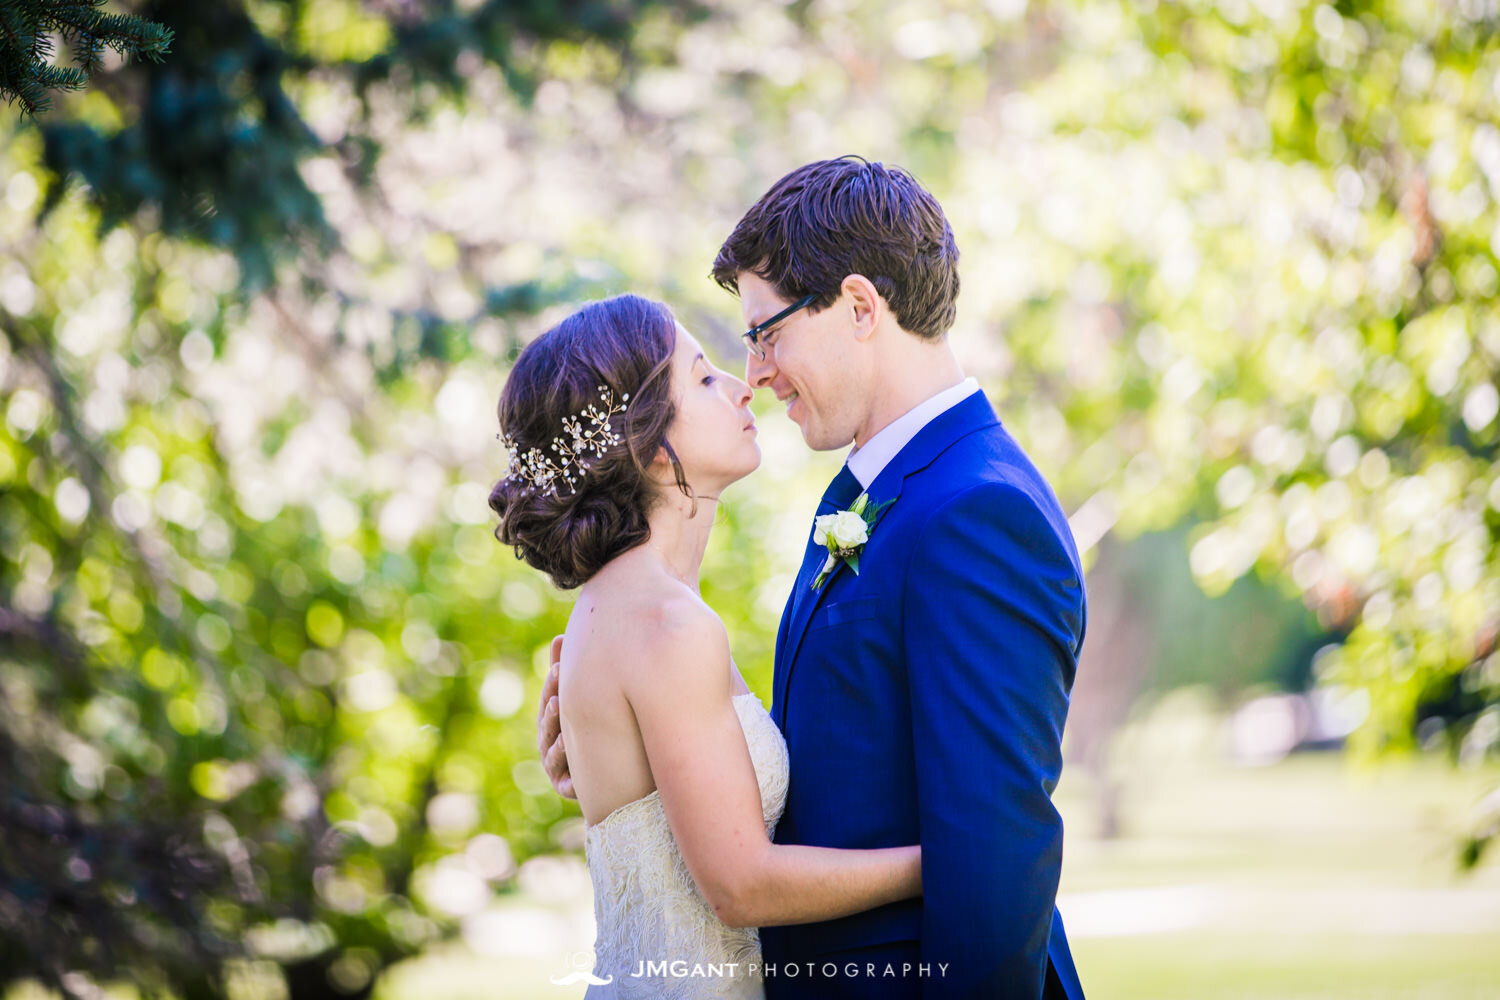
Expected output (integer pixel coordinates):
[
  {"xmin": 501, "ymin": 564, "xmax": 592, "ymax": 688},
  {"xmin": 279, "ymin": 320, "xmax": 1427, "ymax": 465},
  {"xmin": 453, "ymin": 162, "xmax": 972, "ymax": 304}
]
[{"xmin": 489, "ymin": 295, "xmax": 921, "ymax": 999}]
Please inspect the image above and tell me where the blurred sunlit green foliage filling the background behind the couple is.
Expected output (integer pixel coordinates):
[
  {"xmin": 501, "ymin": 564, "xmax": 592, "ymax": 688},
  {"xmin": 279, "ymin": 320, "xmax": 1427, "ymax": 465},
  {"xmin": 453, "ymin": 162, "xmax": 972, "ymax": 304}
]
[{"xmin": 0, "ymin": 0, "xmax": 1500, "ymax": 997}]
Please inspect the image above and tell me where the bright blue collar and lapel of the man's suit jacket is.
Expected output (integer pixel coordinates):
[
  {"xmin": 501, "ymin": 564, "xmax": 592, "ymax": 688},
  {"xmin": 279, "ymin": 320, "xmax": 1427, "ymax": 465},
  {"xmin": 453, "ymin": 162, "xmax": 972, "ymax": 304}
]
[{"xmin": 773, "ymin": 393, "xmax": 999, "ymax": 732}]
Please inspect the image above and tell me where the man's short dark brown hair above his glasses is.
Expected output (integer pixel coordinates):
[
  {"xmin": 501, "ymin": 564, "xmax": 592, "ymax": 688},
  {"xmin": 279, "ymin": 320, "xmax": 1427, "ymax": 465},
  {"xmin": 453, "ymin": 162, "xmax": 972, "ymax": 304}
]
[{"xmin": 713, "ymin": 156, "xmax": 959, "ymax": 340}]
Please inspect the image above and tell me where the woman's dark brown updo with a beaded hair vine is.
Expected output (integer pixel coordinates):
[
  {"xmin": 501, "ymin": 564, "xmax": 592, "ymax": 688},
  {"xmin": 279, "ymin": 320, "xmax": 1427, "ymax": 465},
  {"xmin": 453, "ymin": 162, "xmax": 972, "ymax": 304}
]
[{"xmin": 489, "ymin": 295, "xmax": 692, "ymax": 589}]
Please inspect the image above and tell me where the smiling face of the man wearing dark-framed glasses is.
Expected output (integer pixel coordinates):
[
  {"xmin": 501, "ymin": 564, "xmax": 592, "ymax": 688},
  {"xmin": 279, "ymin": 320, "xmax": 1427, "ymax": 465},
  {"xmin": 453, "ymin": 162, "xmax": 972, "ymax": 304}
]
[{"xmin": 740, "ymin": 271, "xmax": 866, "ymax": 451}]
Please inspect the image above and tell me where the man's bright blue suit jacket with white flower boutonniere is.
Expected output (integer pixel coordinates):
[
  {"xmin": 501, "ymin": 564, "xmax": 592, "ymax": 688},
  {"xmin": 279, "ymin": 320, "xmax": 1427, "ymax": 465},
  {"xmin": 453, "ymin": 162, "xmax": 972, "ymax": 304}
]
[{"xmin": 761, "ymin": 393, "xmax": 1086, "ymax": 1000}]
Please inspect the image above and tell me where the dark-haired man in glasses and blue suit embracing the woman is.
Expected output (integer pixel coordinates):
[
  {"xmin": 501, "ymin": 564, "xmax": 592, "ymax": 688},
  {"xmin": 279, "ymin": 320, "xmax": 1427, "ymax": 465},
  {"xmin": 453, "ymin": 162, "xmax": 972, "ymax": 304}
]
[{"xmin": 539, "ymin": 157, "xmax": 1086, "ymax": 1000}]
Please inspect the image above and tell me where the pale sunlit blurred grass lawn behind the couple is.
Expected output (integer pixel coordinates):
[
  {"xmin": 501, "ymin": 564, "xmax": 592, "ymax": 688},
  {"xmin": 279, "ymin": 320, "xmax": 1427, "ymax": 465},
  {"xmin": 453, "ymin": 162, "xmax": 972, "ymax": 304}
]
[{"xmin": 377, "ymin": 700, "xmax": 1500, "ymax": 1000}]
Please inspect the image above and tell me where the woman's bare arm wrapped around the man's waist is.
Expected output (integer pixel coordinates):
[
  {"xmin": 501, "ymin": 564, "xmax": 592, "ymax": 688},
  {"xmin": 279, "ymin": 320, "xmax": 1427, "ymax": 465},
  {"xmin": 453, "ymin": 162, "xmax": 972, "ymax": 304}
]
[{"xmin": 626, "ymin": 601, "xmax": 921, "ymax": 927}]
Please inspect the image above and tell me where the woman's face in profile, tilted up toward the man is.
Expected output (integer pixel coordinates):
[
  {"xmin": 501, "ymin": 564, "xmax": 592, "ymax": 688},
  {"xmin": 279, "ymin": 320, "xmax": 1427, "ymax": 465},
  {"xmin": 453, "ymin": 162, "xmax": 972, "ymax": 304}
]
[{"xmin": 666, "ymin": 324, "xmax": 761, "ymax": 496}]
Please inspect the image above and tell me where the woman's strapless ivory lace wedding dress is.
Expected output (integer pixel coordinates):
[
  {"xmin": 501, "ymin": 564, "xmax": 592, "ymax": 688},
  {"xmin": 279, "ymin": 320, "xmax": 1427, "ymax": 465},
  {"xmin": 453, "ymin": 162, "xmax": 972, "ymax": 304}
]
[{"xmin": 584, "ymin": 693, "xmax": 788, "ymax": 1000}]
